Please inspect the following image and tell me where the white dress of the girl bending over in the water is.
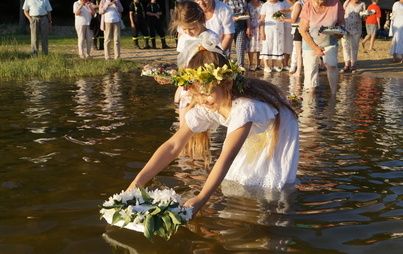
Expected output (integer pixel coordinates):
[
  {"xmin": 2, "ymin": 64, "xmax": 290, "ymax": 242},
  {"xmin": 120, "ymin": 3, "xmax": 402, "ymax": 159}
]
[{"xmin": 185, "ymin": 98, "xmax": 299, "ymax": 189}]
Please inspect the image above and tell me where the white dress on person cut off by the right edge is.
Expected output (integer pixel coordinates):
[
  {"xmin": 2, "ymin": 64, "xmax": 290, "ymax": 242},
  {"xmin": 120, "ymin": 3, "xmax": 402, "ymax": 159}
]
[{"xmin": 389, "ymin": 2, "xmax": 403, "ymax": 56}]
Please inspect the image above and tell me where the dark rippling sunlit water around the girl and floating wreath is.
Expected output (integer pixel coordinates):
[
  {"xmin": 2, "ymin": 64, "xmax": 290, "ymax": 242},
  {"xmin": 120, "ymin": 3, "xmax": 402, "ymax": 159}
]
[{"xmin": 0, "ymin": 73, "xmax": 403, "ymax": 253}]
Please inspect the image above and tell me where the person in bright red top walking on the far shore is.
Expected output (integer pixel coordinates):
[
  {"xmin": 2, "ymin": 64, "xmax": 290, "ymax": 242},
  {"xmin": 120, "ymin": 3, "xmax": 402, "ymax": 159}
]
[{"xmin": 361, "ymin": 0, "xmax": 381, "ymax": 52}]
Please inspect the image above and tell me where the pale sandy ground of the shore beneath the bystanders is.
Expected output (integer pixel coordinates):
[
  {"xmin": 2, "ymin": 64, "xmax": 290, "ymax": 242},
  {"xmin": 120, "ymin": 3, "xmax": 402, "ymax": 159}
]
[{"xmin": 89, "ymin": 40, "xmax": 403, "ymax": 79}]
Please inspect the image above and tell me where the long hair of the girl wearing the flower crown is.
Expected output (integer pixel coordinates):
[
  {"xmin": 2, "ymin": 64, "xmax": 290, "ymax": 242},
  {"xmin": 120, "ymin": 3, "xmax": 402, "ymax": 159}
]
[{"xmin": 184, "ymin": 50, "xmax": 298, "ymax": 166}]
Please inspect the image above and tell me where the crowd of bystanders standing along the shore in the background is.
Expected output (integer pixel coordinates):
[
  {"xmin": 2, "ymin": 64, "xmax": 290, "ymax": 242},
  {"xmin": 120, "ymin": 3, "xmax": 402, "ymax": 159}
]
[{"xmin": 23, "ymin": 0, "xmax": 403, "ymax": 82}]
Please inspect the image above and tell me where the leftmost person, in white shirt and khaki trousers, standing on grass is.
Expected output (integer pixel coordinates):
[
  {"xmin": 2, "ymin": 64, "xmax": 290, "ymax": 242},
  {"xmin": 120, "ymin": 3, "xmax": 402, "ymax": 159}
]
[{"xmin": 22, "ymin": 0, "xmax": 52, "ymax": 56}]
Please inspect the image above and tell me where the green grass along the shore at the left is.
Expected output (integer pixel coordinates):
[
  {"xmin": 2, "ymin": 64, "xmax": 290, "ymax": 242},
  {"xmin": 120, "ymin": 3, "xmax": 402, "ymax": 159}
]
[{"xmin": 0, "ymin": 35, "xmax": 147, "ymax": 80}]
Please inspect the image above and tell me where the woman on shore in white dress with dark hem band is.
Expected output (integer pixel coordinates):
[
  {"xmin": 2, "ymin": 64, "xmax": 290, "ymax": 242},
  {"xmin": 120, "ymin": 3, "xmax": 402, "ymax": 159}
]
[{"xmin": 260, "ymin": 0, "xmax": 286, "ymax": 72}]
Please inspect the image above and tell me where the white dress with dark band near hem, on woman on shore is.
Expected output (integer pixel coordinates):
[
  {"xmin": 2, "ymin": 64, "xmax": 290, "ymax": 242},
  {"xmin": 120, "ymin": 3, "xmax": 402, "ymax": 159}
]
[{"xmin": 260, "ymin": 1, "xmax": 285, "ymax": 60}]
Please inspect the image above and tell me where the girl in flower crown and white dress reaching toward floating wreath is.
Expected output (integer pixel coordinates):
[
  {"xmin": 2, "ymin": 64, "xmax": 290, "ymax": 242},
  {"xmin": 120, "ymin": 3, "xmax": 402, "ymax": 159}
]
[{"xmin": 128, "ymin": 43, "xmax": 299, "ymax": 215}]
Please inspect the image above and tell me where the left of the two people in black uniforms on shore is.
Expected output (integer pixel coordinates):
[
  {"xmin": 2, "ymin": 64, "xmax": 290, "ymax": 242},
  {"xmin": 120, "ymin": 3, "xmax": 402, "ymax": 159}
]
[{"xmin": 129, "ymin": 0, "xmax": 151, "ymax": 49}]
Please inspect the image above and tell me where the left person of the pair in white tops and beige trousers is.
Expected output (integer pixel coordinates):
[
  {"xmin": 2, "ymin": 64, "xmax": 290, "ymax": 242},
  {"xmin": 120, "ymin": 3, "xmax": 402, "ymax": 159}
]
[{"xmin": 73, "ymin": 0, "xmax": 95, "ymax": 58}]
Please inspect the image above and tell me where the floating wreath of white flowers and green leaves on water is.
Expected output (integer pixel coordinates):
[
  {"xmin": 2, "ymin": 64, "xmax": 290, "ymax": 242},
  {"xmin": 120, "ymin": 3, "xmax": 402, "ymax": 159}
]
[{"xmin": 100, "ymin": 188, "xmax": 193, "ymax": 241}]
